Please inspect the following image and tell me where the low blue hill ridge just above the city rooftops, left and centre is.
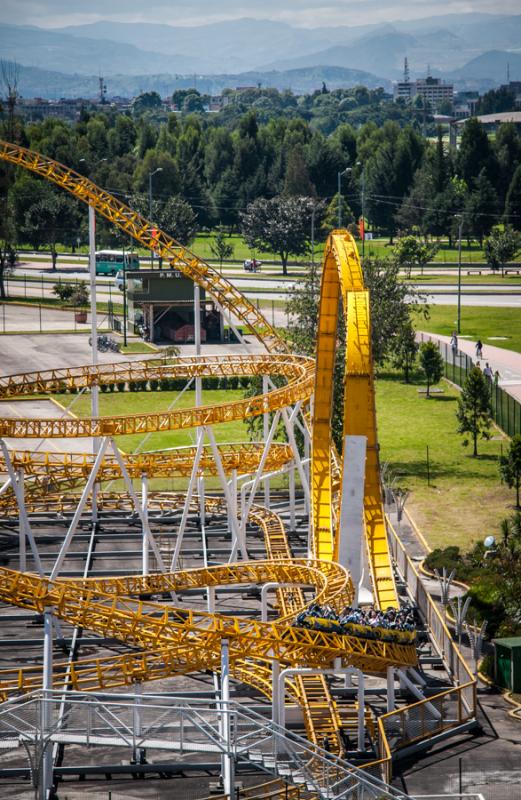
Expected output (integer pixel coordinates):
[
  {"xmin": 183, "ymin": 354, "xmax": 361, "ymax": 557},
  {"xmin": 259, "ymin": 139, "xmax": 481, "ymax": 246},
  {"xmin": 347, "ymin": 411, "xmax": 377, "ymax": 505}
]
[{"xmin": 11, "ymin": 66, "xmax": 391, "ymax": 100}]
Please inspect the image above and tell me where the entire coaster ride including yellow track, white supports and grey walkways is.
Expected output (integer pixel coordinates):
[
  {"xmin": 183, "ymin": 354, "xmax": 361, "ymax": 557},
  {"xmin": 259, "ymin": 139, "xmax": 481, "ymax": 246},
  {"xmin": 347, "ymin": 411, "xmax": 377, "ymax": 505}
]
[{"xmin": 0, "ymin": 142, "xmax": 475, "ymax": 800}]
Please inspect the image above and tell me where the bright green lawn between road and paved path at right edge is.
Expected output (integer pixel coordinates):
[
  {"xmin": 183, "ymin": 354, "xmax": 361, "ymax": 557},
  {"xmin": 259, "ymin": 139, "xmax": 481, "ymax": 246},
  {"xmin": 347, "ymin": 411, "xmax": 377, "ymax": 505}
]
[{"xmin": 414, "ymin": 305, "xmax": 521, "ymax": 352}]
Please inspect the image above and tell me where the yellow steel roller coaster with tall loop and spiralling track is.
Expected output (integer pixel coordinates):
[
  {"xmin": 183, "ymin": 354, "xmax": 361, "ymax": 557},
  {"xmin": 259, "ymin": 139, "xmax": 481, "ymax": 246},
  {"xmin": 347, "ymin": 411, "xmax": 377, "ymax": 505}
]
[{"xmin": 0, "ymin": 142, "xmax": 474, "ymax": 797}]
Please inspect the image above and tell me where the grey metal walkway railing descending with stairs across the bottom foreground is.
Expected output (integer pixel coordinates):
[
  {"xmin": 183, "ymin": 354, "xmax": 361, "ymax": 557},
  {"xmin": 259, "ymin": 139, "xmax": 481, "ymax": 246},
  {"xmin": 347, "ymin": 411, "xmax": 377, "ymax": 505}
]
[{"xmin": 0, "ymin": 692, "xmax": 418, "ymax": 800}]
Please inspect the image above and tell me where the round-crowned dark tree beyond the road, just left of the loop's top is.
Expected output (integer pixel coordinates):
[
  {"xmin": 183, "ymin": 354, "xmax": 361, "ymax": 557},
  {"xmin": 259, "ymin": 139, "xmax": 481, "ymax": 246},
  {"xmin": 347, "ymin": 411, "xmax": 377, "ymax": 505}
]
[{"xmin": 241, "ymin": 196, "xmax": 315, "ymax": 275}]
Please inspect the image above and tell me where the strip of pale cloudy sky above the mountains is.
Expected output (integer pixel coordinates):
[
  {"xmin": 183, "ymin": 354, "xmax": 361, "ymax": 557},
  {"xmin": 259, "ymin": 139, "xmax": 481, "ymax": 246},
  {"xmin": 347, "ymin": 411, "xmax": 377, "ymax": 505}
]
[{"xmin": 0, "ymin": 0, "xmax": 521, "ymax": 28}]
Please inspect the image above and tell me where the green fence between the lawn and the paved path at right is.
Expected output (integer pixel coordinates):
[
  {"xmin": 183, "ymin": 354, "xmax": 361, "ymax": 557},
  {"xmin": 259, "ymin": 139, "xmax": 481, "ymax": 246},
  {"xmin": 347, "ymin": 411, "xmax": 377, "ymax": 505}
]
[{"xmin": 422, "ymin": 335, "xmax": 521, "ymax": 436}]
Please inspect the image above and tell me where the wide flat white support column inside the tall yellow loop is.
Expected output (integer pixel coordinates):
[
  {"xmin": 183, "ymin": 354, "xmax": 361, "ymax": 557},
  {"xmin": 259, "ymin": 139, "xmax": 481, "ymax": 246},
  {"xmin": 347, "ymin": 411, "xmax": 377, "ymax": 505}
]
[{"xmin": 338, "ymin": 436, "xmax": 367, "ymax": 607}]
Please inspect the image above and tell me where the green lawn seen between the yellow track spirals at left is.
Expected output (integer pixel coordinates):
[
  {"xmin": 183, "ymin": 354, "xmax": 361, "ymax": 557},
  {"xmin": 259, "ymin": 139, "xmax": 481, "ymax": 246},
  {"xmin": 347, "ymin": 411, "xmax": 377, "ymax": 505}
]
[{"xmin": 55, "ymin": 389, "xmax": 249, "ymax": 453}]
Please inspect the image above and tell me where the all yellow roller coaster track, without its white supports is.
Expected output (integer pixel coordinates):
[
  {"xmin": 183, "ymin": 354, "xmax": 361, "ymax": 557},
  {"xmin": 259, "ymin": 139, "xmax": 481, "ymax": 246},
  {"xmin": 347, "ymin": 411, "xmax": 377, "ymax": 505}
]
[{"xmin": 0, "ymin": 142, "xmax": 416, "ymax": 764}]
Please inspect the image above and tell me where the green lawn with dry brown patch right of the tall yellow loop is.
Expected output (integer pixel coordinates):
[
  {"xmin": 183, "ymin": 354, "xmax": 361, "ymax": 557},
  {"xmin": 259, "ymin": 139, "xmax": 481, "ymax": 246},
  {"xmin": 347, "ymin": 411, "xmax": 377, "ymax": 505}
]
[{"xmin": 376, "ymin": 373, "xmax": 514, "ymax": 549}]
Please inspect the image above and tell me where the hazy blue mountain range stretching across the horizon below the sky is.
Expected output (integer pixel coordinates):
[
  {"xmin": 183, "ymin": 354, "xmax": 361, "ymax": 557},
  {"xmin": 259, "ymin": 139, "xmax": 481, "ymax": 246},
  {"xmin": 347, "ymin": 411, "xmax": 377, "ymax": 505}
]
[{"xmin": 0, "ymin": 14, "xmax": 521, "ymax": 97}]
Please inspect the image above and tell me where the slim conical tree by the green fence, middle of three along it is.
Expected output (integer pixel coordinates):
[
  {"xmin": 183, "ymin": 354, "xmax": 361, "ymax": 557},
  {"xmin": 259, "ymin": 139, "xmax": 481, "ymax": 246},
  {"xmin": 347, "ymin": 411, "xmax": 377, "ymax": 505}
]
[{"xmin": 456, "ymin": 367, "xmax": 492, "ymax": 457}]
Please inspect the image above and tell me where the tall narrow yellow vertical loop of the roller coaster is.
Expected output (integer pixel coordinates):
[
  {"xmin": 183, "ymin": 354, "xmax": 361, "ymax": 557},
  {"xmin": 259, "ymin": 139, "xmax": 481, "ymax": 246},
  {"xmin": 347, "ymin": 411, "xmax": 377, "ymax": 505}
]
[{"xmin": 312, "ymin": 231, "xmax": 398, "ymax": 608}]
